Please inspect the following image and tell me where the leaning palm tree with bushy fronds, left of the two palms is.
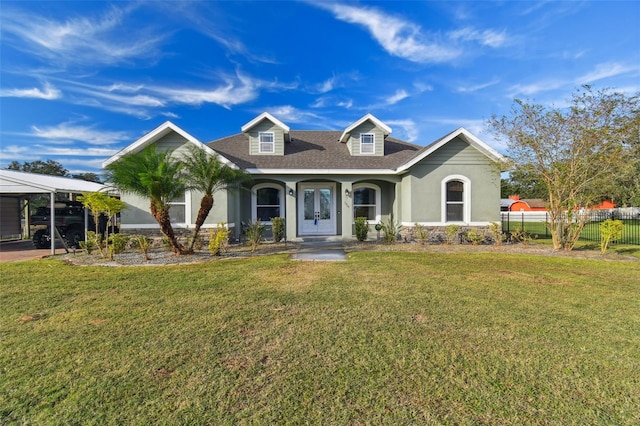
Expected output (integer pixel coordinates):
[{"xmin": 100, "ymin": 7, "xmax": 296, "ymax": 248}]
[{"xmin": 106, "ymin": 145, "xmax": 187, "ymax": 254}]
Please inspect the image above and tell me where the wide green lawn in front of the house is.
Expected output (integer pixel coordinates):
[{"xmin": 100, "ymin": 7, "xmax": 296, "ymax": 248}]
[{"xmin": 0, "ymin": 252, "xmax": 640, "ymax": 425}]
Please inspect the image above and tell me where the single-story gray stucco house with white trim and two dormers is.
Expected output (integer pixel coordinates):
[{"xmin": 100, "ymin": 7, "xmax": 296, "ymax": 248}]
[{"xmin": 103, "ymin": 112, "xmax": 503, "ymax": 240}]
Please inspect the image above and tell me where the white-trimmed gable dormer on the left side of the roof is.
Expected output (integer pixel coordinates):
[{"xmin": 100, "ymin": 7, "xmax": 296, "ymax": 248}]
[{"xmin": 242, "ymin": 112, "xmax": 290, "ymax": 155}]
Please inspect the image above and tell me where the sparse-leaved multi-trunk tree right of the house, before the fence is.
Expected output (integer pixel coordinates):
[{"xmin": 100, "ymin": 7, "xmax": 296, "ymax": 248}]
[{"xmin": 488, "ymin": 86, "xmax": 640, "ymax": 250}]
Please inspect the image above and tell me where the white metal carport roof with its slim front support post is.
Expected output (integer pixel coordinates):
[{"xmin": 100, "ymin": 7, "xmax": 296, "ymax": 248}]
[{"xmin": 0, "ymin": 170, "xmax": 112, "ymax": 254}]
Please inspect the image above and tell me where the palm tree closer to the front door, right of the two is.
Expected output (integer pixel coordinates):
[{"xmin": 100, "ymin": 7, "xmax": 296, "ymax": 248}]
[{"xmin": 182, "ymin": 146, "xmax": 251, "ymax": 253}]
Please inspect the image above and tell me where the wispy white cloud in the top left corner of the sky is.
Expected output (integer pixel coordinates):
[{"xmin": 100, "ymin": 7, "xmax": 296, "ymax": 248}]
[{"xmin": 2, "ymin": 7, "xmax": 164, "ymax": 65}]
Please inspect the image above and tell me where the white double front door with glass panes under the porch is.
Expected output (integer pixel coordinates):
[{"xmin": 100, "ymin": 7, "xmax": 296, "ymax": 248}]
[{"xmin": 298, "ymin": 183, "xmax": 336, "ymax": 235}]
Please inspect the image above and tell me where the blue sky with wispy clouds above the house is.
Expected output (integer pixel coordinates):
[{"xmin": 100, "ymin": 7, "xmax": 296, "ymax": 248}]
[{"xmin": 0, "ymin": 0, "xmax": 640, "ymax": 173}]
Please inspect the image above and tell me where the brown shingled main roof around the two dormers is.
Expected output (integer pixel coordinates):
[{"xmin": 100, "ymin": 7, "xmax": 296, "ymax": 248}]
[{"xmin": 207, "ymin": 130, "xmax": 426, "ymax": 170}]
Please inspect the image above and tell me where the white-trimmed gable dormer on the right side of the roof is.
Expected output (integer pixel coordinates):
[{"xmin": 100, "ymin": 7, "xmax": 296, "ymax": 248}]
[{"xmin": 340, "ymin": 114, "xmax": 391, "ymax": 156}]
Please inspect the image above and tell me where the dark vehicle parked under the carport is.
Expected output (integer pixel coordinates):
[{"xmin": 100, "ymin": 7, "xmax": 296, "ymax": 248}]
[{"xmin": 31, "ymin": 201, "xmax": 106, "ymax": 248}]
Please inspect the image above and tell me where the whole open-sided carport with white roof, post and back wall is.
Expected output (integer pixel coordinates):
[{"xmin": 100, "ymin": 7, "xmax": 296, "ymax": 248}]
[{"xmin": 0, "ymin": 170, "xmax": 109, "ymax": 254}]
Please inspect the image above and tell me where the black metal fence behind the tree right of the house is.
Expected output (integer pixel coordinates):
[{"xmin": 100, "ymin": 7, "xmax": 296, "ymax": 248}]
[{"xmin": 502, "ymin": 207, "xmax": 640, "ymax": 245}]
